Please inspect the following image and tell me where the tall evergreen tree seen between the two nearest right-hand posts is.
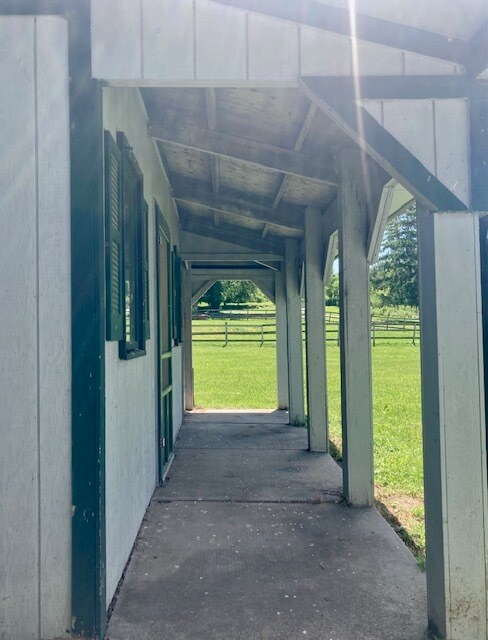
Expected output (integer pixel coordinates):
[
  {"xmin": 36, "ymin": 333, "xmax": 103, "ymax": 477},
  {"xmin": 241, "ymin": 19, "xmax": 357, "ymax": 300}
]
[{"xmin": 371, "ymin": 208, "xmax": 418, "ymax": 307}]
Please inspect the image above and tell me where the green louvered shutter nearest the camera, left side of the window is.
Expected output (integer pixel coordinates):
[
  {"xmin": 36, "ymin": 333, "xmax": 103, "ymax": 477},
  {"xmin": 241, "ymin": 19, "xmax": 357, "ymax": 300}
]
[{"xmin": 105, "ymin": 131, "xmax": 124, "ymax": 340}]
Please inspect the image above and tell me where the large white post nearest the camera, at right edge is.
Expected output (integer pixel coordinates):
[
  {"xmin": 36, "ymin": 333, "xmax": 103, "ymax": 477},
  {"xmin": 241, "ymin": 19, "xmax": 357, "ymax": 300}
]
[{"xmin": 418, "ymin": 208, "xmax": 488, "ymax": 640}]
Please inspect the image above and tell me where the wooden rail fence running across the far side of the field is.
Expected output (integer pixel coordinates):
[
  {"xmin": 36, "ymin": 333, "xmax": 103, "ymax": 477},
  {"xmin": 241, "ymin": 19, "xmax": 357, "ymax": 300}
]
[{"xmin": 192, "ymin": 312, "xmax": 420, "ymax": 346}]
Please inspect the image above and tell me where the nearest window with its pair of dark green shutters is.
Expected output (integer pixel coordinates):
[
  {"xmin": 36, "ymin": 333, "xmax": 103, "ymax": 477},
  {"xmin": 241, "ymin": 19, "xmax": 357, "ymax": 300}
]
[{"xmin": 105, "ymin": 131, "xmax": 150, "ymax": 360}]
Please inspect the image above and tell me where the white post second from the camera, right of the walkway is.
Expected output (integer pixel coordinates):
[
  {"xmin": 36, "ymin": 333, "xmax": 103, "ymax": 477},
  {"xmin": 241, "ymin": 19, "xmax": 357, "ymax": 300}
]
[{"xmin": 339, "ymin": 150, "xmax": 374, "ymax": 506}]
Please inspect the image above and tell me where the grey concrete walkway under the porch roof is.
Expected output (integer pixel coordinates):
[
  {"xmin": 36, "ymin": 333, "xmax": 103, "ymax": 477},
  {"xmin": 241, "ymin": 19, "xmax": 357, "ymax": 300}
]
[{"xmin": 107, "ymin": 412, "xmax": 426, "ymax": 640}]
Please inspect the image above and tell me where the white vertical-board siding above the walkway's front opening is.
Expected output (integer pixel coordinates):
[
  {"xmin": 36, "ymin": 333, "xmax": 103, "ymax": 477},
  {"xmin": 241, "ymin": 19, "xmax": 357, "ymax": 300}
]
[{"xmin": 92, "ymin": 0, "xmax": 463, "ymax": 86}]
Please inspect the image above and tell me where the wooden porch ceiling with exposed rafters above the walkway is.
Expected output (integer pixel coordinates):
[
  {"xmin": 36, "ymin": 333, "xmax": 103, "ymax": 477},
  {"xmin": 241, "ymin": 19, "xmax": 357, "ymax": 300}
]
[{"xmin": 142, "ymin": 88, "xmax": 354, "ymax": 251}]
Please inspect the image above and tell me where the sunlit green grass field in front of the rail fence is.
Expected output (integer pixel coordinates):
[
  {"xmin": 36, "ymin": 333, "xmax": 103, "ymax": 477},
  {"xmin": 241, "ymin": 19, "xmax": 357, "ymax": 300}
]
[{"xmin": 194, "ymin": 341, "xmax": 425, "ymax": 557}]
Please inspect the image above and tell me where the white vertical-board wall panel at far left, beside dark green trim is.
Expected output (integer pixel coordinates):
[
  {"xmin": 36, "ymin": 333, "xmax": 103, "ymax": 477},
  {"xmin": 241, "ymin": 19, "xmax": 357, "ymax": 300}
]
[{"xmin": 0, "ymin": 17, "xmax": 71, "ymax": 640}]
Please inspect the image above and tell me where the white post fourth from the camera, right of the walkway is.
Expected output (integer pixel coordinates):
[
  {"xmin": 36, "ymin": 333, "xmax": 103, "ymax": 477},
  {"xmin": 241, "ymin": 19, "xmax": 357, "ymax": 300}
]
[{"xmin": 285, "ymin": 238, "xmax": 305, "ymax": 425}]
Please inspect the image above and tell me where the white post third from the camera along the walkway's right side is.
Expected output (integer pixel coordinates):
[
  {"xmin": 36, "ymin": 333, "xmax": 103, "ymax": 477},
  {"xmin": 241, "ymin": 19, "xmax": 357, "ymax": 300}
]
[{"xmin": 305, "ymin": 207, "xmax": 329, "ymax": 452}]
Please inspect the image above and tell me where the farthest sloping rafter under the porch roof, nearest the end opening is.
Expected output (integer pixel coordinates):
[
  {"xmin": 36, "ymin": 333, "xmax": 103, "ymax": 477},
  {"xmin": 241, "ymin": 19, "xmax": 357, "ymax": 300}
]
[{"xmin": 181, "ymin": 211, "xmax": 284, "ymax": 256}]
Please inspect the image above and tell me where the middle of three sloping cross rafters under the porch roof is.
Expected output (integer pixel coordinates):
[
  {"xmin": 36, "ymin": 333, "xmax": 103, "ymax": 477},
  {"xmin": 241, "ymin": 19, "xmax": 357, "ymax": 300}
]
[{"xmin": 173, "ymin": 194, "xmax": 303, "ymax": 232}]
